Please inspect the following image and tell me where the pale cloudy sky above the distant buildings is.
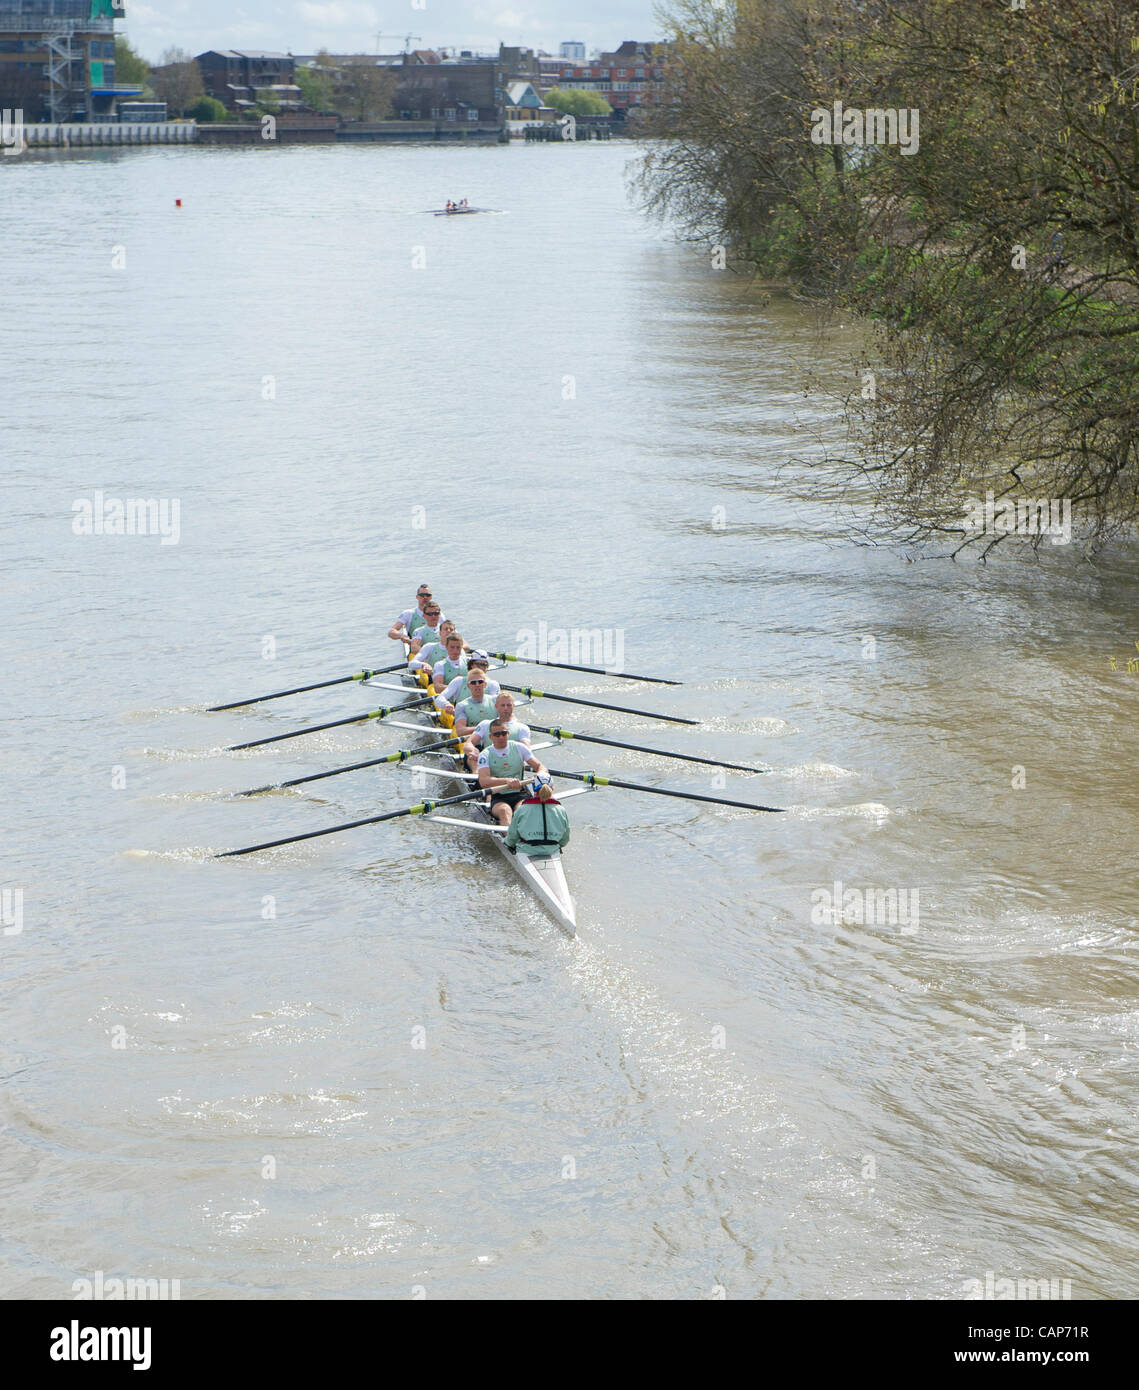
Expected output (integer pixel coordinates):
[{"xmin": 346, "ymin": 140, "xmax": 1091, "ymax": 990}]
[{"xmin": 115, "ymin": 0, "xmax": 661, "ymax": 63}]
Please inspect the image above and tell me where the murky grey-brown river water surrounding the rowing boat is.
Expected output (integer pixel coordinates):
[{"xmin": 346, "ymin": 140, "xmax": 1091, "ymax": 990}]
[{"xmin": 0, "ymin": 135, "xmax": 1139, "ymax": 1300}]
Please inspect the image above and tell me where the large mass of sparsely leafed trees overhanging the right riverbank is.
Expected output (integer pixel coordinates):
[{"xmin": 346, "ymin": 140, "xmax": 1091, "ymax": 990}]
[{"xmin": 643, "ymin": 0, "xmax": 1139, "ymax": 550}]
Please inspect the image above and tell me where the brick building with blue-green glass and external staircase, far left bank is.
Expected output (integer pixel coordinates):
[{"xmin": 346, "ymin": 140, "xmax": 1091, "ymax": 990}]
[{"xmin": 0, "ymin": 0, "xmax": 142, "ymax": 122}]
